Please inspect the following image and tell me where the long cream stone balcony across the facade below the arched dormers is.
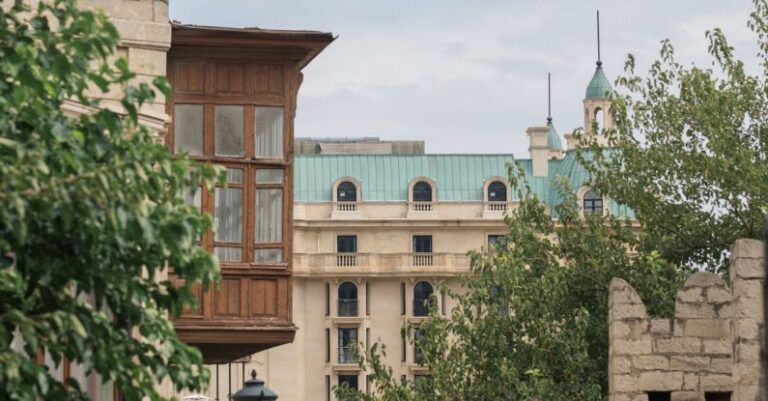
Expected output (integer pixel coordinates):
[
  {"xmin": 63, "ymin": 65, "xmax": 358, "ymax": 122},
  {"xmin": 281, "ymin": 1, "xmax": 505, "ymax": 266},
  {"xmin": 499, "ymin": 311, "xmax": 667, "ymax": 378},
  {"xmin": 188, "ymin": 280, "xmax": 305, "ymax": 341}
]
[{"xmin": 293, "ymin": 252, "xmax": 469, "ymax": 274}]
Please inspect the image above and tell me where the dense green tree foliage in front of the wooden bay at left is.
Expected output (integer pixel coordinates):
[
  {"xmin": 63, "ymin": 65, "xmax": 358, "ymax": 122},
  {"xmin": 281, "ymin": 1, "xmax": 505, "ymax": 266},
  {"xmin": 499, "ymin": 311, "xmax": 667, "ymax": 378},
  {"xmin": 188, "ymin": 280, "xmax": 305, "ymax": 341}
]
[{"xmin": 0, "ymin": 0, "xmax": 219, "ymax": 400}]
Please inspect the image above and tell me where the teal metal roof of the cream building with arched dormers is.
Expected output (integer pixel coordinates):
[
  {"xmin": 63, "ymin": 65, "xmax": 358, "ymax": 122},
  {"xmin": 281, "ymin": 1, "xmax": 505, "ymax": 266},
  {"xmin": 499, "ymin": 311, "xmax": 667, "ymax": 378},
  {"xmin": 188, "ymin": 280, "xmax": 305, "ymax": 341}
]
[{"xmin": 294, "ymin": 151, "xmax": 631, "ymax": 216}]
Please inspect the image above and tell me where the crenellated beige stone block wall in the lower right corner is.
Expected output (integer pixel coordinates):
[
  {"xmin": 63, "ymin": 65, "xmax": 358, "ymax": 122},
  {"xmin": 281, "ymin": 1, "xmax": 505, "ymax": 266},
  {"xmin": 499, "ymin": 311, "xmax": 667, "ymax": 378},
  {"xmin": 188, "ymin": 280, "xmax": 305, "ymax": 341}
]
[{"xmin": 608, "ymin": 240, "xmax": 765, "ymax": 401}]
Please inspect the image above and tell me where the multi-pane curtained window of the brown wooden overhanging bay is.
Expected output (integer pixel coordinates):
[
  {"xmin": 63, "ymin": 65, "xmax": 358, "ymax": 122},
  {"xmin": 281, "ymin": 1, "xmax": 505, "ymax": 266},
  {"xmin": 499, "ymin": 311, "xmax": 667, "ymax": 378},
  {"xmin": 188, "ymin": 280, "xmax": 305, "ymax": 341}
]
[{"xmin": 170, "ymin": 101, "xmax": 287, "ymax": 264}]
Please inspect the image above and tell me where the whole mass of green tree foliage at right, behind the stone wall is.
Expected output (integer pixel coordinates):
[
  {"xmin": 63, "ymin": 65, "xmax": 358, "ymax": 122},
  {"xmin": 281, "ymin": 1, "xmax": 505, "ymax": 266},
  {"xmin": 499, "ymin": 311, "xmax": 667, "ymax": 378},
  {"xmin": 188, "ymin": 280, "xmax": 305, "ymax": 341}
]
[{"xmin": 337, "ymin": 0, "xmax": 768, "ymax": 401}]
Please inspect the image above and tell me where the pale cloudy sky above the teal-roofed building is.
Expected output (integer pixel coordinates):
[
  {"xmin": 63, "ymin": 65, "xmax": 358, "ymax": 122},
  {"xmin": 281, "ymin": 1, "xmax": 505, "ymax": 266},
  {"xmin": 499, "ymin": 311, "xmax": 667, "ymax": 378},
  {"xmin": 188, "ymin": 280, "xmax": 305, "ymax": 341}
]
[{"xmin": 170, "ymin": 0, "xmax": 757, "ymax": 157}]
